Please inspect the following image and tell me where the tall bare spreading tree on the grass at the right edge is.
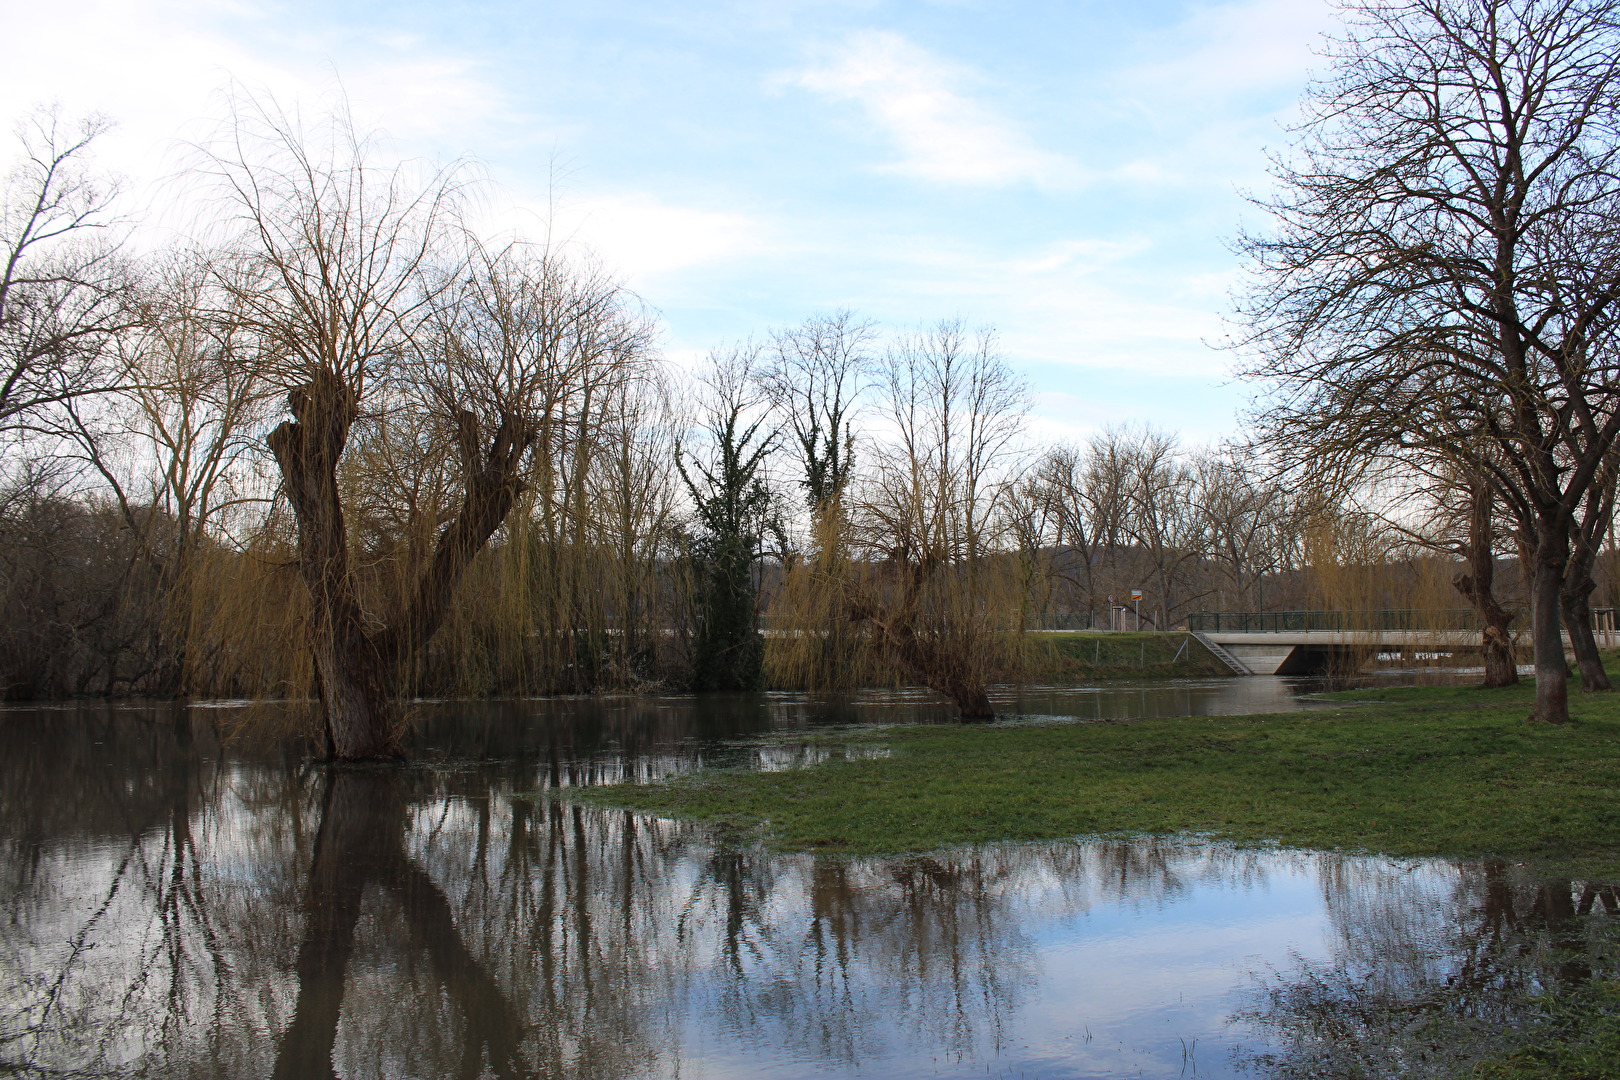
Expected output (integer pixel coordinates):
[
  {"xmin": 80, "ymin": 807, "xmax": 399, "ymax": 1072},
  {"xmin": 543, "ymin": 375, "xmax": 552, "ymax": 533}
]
[{"xmin": 1239, "ymin": 0, "xmax": 1620, "ymax": 724}]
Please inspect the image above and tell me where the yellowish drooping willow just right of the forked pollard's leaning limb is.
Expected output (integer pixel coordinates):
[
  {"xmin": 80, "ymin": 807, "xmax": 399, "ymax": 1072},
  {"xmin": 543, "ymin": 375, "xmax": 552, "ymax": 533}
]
[{"xmin": 411, "ymin": 261, "xmax": 672, "ymax": 693}]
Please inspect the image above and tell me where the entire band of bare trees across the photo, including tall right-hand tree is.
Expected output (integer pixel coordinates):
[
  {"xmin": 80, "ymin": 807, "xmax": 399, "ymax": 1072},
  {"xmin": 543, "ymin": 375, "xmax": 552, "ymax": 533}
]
[{"xmin": 12, "ymin": 0, "xmax": 1620, "ymax": 758}]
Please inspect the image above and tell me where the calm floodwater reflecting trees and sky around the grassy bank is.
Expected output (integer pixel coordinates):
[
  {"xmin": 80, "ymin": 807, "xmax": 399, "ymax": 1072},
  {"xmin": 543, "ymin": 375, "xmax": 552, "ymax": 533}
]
[{"xmin": 0, "ymin": 678, "xmax": 1620, "ymax": 1080}]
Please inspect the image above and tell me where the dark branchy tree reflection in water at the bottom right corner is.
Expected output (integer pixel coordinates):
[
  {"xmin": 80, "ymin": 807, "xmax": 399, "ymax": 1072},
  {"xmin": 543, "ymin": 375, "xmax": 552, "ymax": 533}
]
[{"xmin": 1238, "ymin": 860, "xmax": 1620, "ymax": 1080}]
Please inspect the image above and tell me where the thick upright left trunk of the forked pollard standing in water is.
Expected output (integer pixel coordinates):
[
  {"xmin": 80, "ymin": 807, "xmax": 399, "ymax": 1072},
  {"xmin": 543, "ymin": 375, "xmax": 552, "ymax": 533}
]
[{"xmin": 267, "ymin": 372, "xmax": 400, "ymax": 761}]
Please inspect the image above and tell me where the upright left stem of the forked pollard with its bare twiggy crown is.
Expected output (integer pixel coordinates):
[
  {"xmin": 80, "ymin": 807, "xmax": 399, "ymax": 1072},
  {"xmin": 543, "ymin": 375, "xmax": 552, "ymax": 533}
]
[{"xmin": 211, "ymin": 100, "xmax": 463, "ymax": 758}]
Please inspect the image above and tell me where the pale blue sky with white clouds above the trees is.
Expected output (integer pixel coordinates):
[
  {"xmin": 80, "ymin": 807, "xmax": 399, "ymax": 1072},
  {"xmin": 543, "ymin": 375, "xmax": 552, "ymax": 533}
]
[{"xmin": 0, "ymin": 0, "xmax": 1335, "ymax": 444}]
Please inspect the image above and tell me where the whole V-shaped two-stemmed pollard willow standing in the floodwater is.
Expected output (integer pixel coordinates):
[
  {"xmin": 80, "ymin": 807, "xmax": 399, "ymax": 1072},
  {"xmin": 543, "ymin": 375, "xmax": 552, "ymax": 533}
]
[{"xmin": 209, "ymin": 102, "xmax": 644, "ymax": 759}]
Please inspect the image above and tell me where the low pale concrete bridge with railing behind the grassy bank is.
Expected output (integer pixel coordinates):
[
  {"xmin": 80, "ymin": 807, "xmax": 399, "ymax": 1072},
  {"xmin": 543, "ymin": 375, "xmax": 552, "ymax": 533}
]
[{"xmin": 1187, "ymin": 607, "xmax": 1620, "ymax": 675}]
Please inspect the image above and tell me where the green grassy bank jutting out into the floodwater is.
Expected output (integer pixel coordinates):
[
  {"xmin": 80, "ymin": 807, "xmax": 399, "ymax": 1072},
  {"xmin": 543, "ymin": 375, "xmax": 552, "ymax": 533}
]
[{"xmin": 580, "ymin": 667, "xmax": 1620, "ymax": 879}]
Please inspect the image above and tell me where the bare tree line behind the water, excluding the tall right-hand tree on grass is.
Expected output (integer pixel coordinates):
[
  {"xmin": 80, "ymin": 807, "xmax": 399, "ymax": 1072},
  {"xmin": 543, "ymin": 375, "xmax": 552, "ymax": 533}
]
[{"xmin": 0, "ymin": 100, "xmax": 1328, "ymax": 735}]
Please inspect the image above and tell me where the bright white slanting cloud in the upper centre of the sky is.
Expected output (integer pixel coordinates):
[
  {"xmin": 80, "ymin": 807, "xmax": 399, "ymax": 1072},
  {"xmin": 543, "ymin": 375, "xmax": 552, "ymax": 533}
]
[{"xmin": 789, "ymin": 31, "xmax": 1081, "ymax": 186}]
